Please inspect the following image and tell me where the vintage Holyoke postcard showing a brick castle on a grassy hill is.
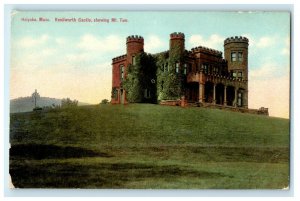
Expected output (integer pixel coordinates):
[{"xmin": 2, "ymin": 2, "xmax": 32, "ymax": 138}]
[{"xmin": 9, "ymin": 10, "xmax": 290, "ymax": 189}]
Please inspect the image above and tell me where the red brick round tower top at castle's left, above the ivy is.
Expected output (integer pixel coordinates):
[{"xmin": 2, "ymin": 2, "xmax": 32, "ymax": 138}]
[{"xmin": 126, "ymin": 35, "xmax": 144, "ymax": 64}]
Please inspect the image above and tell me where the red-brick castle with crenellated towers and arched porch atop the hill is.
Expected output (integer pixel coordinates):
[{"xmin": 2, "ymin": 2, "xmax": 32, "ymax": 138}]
[{"xmin": 111, "ymin": 32, "xmax": 268, "ymax": 114}]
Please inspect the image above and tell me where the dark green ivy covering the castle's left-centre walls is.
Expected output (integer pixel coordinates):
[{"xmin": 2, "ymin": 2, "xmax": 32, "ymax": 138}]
[{"xmin": 123, "ymin": 43, "xmax": 186, "ymax": 103}]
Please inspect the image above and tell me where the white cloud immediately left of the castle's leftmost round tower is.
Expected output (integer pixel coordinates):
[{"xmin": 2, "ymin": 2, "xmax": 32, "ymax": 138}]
[{"xmin": 77, "ymin": 34, "xmax": 124, "ymax": 52}]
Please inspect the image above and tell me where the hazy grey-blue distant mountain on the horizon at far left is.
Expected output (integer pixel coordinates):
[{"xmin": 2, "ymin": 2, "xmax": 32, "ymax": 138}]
[{"xmin": 10, "ymin": 96, "xmax": 89, "ymax": 113}]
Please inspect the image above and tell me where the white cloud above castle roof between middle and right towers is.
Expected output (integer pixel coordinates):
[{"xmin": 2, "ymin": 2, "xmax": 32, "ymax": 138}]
[{"xmin": 188, "ymin": 34, "xmax": 225, "ymax": 49}]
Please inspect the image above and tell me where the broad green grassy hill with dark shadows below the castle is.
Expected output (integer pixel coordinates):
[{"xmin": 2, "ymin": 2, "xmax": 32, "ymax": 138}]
[{"xmin": 10, "ymin": 104, "xmax": 290, "ymax": 189}]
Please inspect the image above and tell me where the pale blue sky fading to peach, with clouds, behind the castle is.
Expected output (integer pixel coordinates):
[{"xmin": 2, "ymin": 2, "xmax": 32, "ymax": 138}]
[{"xmin": 10, "ymin": 11, "xmax": 290, "ymax": 118}]
